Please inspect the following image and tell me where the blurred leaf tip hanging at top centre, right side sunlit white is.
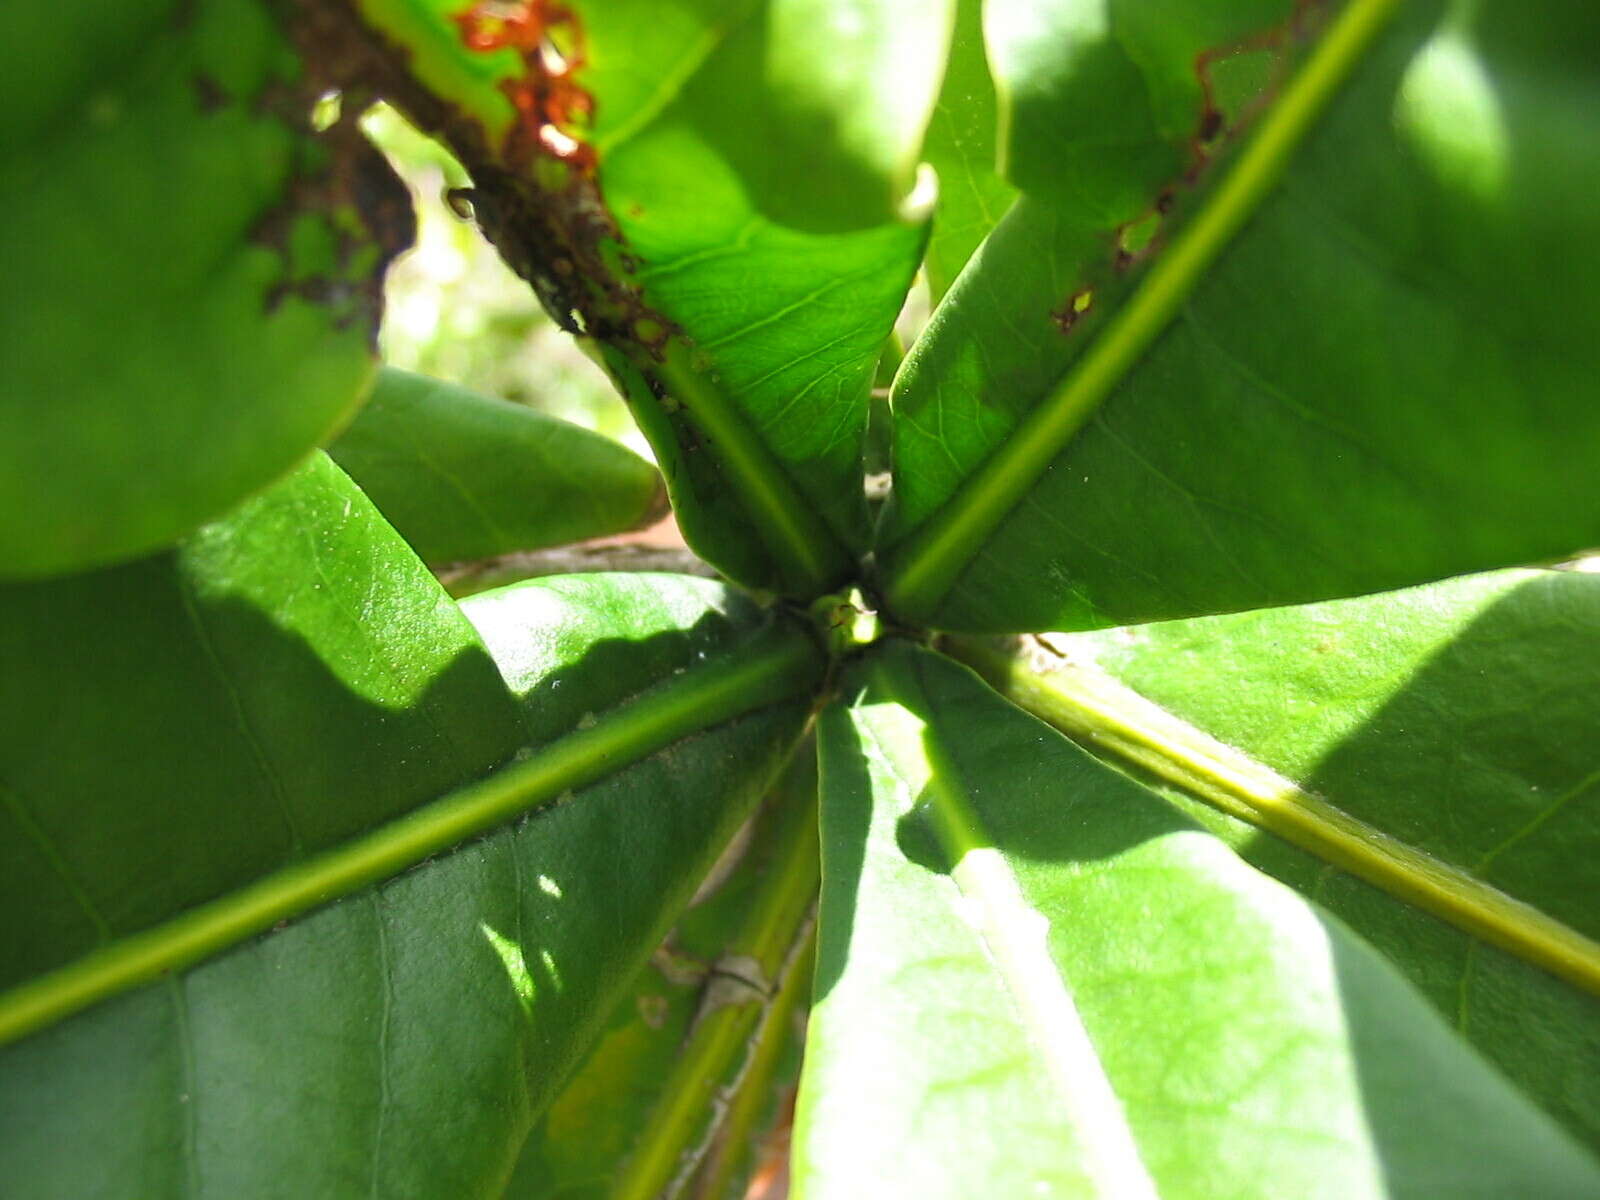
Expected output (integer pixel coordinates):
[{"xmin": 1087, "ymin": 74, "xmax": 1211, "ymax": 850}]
[{"xmin": 578, "ymin": 0, "xmax": 955, "ymax": 232}]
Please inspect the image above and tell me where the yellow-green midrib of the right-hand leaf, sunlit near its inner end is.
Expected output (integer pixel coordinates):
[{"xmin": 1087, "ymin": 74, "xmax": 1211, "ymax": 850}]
[{"xmin": 947, "ymin": 638, "xmax": 1600, "ymax": 995}]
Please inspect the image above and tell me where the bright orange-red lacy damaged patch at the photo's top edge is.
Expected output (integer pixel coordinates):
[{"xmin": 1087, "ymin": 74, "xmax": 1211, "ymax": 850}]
[{"xmin": 451, "ymin": 0, "xmax": 595, "ymax": 174}]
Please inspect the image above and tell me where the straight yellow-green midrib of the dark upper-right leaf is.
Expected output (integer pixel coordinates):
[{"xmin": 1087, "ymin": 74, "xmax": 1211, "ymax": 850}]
[{"xmin": 883, "ymin": 0, "xmax": 1400, "ymax": 618}]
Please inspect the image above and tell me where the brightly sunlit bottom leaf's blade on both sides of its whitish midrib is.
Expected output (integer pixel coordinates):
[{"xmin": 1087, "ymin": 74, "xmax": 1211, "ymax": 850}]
[{"xmin": 797, "ymin": 646, "xmax": 1595, "ymax": 1195}]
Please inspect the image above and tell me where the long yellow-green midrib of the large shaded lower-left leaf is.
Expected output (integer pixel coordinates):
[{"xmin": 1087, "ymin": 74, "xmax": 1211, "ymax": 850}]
[{"xmin": 0, "ymin": 626, "xmax": 821, "ymax": 1045}]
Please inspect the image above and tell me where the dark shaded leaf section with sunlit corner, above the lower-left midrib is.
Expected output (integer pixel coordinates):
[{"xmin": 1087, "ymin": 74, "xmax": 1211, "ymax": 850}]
[{"xmin": 0, "ymin": 454, "xmax": 523, "ymax": 990}]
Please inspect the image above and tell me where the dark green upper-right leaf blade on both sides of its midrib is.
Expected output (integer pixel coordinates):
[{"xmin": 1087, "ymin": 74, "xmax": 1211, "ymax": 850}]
[{"xmin": 886, "ymin": 0, "xmax": 1597, "ymax": 632}]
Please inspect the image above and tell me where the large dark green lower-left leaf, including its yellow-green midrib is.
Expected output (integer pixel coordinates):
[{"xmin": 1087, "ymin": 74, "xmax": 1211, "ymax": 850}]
[{"xmin": 0, "ymin": 537, "xmax": 819, "ymax": 1197}]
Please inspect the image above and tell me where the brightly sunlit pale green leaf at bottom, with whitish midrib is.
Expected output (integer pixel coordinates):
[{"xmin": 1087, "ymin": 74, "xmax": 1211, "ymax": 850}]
[{"xmin": 795, "ymin": 643, "xmax": 1600, "ymax": 1197}]
